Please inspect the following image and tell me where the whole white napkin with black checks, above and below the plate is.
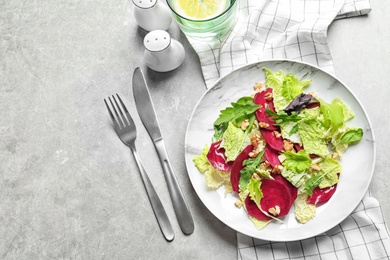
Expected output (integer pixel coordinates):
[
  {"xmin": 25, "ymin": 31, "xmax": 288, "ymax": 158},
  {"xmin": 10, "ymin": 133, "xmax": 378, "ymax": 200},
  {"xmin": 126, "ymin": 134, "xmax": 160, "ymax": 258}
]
[{"xmin": 184, "ymin": 0, "xmax": 390, "ymax": 260}]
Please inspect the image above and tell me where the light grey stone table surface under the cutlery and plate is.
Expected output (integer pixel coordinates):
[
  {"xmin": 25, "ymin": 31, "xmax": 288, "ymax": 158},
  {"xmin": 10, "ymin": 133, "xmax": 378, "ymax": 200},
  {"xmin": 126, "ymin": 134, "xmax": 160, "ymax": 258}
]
[{"xmin": 0, "ymin": 0, "xmax": 390, "ymax": 259}]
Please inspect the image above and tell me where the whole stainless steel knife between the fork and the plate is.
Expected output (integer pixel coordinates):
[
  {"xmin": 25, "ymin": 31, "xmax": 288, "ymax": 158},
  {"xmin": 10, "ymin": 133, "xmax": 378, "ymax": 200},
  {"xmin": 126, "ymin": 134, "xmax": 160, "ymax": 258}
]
[{"xmin": 133, "ymin": 67, "xmax": 194, "ymax": 235}]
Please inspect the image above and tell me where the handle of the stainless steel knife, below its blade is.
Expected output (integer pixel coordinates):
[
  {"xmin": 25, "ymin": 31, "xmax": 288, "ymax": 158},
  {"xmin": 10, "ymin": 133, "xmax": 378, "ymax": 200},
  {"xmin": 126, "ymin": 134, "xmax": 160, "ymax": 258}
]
[{"xmin": 154, "ymin": 139, "xmax": 194, "ymax": 235}]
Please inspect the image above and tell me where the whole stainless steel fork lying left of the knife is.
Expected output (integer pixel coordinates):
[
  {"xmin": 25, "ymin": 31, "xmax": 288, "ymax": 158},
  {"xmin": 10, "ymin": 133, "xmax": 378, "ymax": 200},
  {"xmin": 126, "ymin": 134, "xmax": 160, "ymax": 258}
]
[{"xmin": 104, "ymin": 94, "xmax": 175, "ymax": 241}]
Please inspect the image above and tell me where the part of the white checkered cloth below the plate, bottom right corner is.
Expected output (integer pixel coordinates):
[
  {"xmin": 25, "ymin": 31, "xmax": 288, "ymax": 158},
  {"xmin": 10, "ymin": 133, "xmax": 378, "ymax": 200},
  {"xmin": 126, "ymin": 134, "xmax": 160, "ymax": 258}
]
[{"xmin": 237, "ymin": 190, "xmax": 390, "ymax": 260}]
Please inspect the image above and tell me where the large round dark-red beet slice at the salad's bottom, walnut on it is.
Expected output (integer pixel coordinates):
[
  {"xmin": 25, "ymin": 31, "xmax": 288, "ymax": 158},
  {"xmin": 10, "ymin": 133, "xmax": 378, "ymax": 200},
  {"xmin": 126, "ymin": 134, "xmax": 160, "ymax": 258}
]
[{"xmin": 260, "ymin": 179, "xmax": 292, "ymax": 217}]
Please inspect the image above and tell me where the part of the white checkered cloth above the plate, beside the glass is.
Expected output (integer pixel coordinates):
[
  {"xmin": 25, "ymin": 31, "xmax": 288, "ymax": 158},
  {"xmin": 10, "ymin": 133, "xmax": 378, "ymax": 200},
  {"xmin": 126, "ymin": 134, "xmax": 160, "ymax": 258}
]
[{"xmin": 188, "ymin": 0, "xmax": 371, "ymax": 87}]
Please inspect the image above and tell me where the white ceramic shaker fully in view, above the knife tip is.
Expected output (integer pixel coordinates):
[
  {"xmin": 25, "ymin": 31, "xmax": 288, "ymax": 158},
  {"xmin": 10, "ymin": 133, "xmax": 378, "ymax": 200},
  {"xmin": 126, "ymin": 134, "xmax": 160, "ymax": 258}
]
[{"xmin": 144, "ymin": 30, "xmax": 185, "ymax": 72}]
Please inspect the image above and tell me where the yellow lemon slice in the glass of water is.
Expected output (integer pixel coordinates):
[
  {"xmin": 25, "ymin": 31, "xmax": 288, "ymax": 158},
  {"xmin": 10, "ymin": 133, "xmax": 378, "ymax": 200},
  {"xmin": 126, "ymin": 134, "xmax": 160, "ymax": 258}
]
[{"xmin": 174, "ymin": 0, "xmax": 229, "ymax": 20}]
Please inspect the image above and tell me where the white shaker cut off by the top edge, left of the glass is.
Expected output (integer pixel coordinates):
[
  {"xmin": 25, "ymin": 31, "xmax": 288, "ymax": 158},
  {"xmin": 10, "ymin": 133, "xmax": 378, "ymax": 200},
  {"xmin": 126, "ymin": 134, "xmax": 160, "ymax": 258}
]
[{"xmin": 133, "ymin": 0, "xmax": 172, "ymax": 31}]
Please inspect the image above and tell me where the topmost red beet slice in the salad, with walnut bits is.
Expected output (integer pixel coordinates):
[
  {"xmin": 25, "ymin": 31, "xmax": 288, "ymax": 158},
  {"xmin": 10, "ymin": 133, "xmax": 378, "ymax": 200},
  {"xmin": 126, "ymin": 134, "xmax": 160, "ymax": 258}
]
[{"xmin": 253, "ymin": 88, "xmax": 279, "ymax": 130}]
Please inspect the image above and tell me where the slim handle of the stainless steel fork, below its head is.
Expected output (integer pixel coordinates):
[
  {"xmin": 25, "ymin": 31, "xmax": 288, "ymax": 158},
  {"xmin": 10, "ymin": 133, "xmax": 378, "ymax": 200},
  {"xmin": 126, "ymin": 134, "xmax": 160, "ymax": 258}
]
[{"xmin": 131, "ymin": 147, "xmax": 175, "ymax": 242}]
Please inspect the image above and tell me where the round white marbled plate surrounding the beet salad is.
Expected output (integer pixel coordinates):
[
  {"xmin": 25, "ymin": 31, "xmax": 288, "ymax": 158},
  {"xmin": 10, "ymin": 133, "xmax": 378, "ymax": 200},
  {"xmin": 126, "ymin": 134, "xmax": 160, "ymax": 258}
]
[{"xmin": 185, "ymin": 60, "xmax": 375, "ymax": 241}]
